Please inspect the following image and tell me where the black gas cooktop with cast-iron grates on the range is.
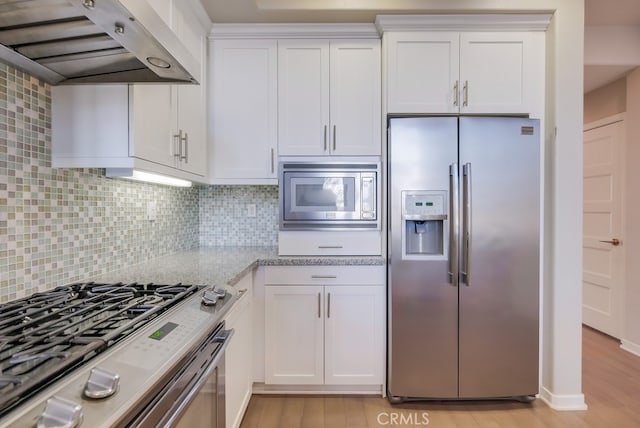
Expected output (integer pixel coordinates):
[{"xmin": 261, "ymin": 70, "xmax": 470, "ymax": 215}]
[{"xmin": 0, "ymin": 282, "xmax": 202, "ymax": 417}]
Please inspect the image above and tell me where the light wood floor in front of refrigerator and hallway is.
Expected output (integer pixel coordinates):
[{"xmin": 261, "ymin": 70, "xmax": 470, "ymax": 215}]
[{"xmin": 241, "ymin": 327, "xmax": 640, "ymax": 428}]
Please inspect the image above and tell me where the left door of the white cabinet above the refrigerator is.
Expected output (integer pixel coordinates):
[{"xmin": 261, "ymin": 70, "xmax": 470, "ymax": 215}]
[{"xmin": 385, "ymin": 32, "xmax": 460, "ymax": 113}]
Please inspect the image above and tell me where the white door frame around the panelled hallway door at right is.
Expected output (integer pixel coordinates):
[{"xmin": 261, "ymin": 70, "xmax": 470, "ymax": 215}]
[{"xmin": 582, "ymin": 113, "xmax": 627, "ymax": 341}]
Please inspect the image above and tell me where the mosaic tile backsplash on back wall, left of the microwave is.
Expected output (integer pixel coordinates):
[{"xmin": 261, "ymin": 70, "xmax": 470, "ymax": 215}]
[{"xmin": 200, "ymin": 186, "xmax": 278, "ymax": 247}]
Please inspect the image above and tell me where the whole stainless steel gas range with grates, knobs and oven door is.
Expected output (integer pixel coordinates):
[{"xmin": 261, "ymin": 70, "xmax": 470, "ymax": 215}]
[{"xmin": 0, "ymin": 282, "xmax": 237, "ymax": 428}]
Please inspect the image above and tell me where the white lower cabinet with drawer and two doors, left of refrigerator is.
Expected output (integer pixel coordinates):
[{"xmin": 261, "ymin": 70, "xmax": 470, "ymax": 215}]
[{"xmin": 265, "ymin": 266, "xmax": 385, "ymax": 385}]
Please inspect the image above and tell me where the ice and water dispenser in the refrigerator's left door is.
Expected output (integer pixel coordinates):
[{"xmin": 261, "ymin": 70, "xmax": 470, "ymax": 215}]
[{"xmin": 402, "ymin": 190, "xmax": 449, "ymax": 260}]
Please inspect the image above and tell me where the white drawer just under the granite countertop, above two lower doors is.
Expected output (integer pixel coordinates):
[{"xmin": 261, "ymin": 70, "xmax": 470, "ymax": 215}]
[{"xmin": 264, "ymin": 265, "xmax": 385, "ymax": 286}]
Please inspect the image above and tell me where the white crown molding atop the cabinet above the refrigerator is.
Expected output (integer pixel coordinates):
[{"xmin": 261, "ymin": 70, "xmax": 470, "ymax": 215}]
[{"xmin": 375, "ymin": 13, "xmax": 553, "ymax": 34}]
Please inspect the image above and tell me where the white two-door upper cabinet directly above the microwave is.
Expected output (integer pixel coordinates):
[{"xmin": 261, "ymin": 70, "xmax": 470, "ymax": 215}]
[{"xmin": 278, "ymin": 39, "xmax": 381, "ymax": 156}]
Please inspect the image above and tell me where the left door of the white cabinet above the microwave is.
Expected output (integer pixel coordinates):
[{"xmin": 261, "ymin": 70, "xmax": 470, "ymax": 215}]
[{"xmin": 278, "ymin": 40, "xmax": 330, "ymax": 155}]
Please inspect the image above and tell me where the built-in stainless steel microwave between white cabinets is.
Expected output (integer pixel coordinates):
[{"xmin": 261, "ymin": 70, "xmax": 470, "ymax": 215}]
[{"xmin": 278, "ymin": 161, "xmax": 380, "ymax": 230}]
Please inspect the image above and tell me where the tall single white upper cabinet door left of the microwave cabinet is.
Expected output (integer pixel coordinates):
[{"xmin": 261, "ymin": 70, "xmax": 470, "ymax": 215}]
[{"xmin": 211, "ymin": 40, "xmax": 278, "ymax": 181}]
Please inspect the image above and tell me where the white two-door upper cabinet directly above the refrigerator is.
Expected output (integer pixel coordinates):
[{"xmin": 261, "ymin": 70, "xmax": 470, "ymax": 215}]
[{"xmin": 384, "ymin": 32, "xmax": 544, "ymax": 114}]
